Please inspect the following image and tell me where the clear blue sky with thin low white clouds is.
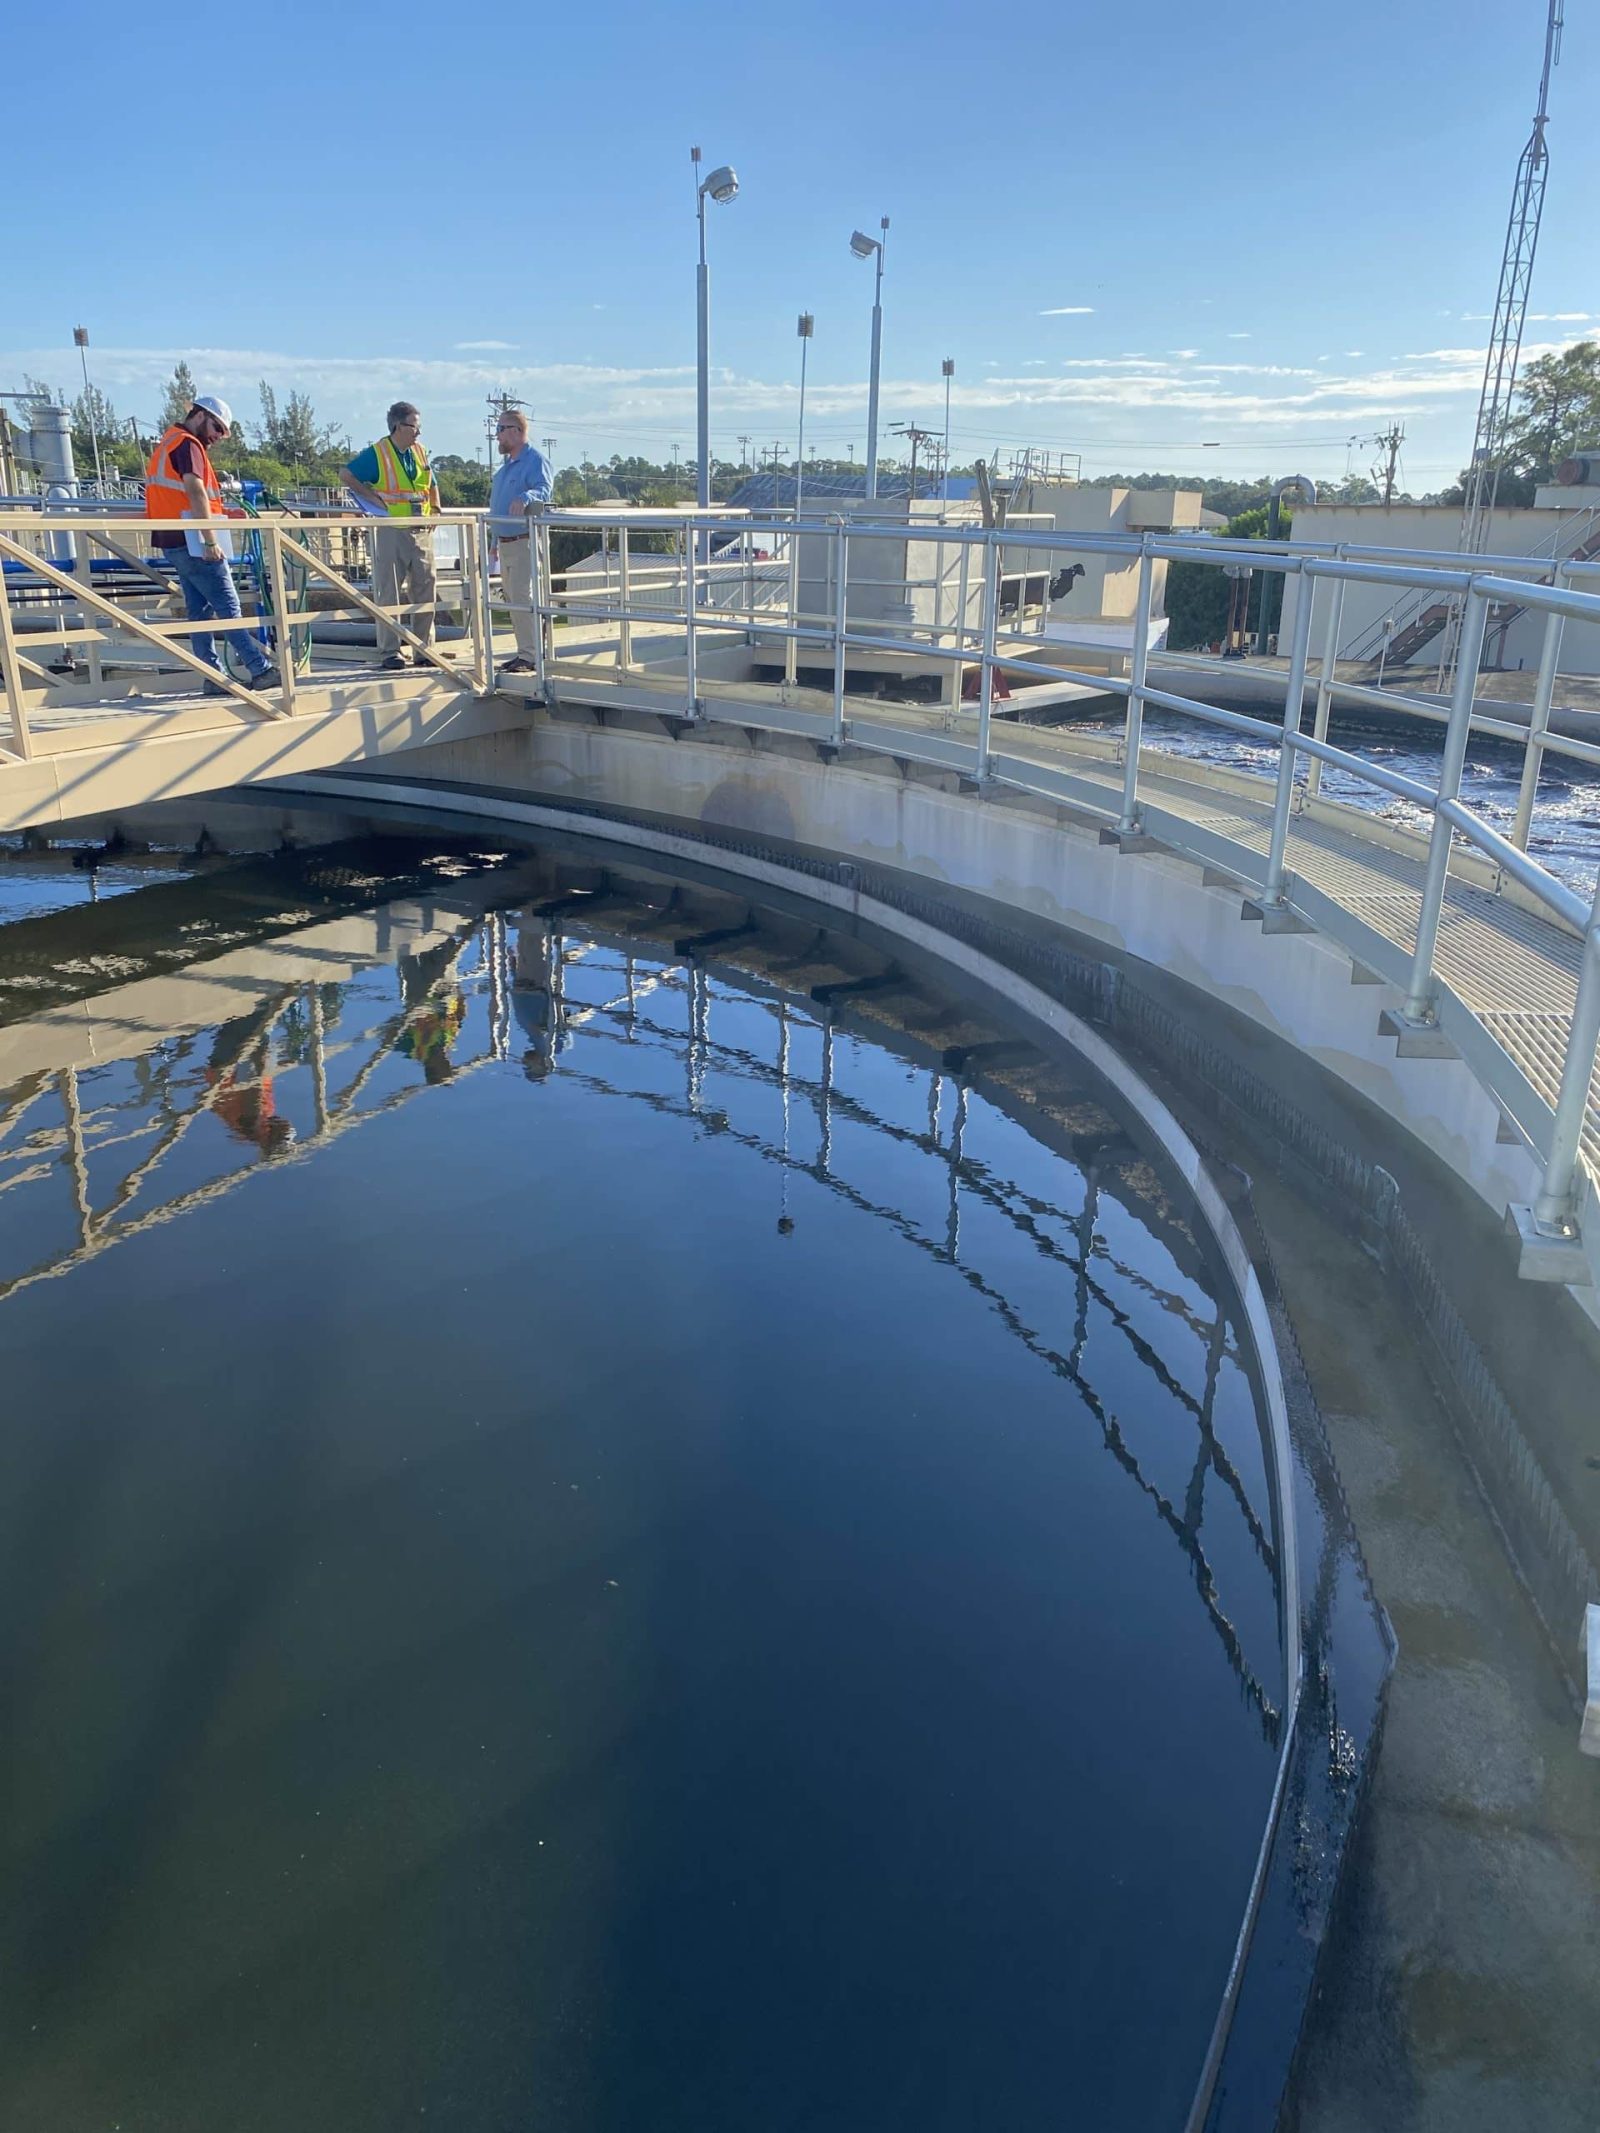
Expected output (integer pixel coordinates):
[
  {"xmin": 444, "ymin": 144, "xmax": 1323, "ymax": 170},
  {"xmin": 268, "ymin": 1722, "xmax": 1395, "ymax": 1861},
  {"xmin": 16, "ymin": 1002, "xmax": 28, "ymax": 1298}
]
[{"xmin": 0, "ymin": 0, "xmax": 1600, "ymax": 491}]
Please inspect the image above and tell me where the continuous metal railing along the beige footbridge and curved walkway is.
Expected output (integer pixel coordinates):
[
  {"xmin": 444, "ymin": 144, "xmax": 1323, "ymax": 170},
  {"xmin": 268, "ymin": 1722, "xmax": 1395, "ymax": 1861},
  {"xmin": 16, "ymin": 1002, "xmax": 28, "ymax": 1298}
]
[{"xmin": 0, "ymin": 508, "xmax": 1600, "ymax": 1226}]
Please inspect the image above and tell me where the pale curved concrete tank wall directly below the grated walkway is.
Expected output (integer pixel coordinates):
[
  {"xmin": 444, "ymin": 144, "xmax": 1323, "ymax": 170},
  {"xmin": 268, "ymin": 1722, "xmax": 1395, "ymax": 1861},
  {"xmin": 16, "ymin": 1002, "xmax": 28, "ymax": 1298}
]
[{"xmin": 379, "ymin": 715, "xmax": 1600, "ymax": 1318}]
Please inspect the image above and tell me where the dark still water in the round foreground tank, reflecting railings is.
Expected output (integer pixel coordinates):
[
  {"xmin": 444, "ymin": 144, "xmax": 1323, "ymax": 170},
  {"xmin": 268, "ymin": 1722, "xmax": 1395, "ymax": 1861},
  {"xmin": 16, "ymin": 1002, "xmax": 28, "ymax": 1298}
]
[{"xmin": 0, "ymin": 855, "xmax": 1282, "ymax": 2133}]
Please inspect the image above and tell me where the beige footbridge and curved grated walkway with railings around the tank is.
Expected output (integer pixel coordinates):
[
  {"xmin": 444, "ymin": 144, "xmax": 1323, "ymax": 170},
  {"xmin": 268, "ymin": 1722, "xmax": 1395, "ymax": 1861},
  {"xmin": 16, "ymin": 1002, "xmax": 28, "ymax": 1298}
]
[{"xmin": 0, "ymin": 510, "xmax": 1600, "ymax": 1282}]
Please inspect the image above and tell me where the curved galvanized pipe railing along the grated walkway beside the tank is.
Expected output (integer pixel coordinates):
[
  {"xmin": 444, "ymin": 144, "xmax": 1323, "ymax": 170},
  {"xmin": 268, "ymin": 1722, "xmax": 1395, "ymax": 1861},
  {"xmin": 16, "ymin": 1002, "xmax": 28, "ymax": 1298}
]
[{"xmin": 514, "ymin": 510, "xmax": 1600, "ymax": 1235}]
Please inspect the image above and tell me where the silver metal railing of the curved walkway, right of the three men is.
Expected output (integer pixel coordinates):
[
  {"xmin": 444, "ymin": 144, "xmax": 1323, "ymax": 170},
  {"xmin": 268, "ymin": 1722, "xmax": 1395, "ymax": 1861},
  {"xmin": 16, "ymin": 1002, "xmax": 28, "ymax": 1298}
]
[{"xmin": 514, "ymin": 510, "xmax": 1600, "ymax": 1239}]
